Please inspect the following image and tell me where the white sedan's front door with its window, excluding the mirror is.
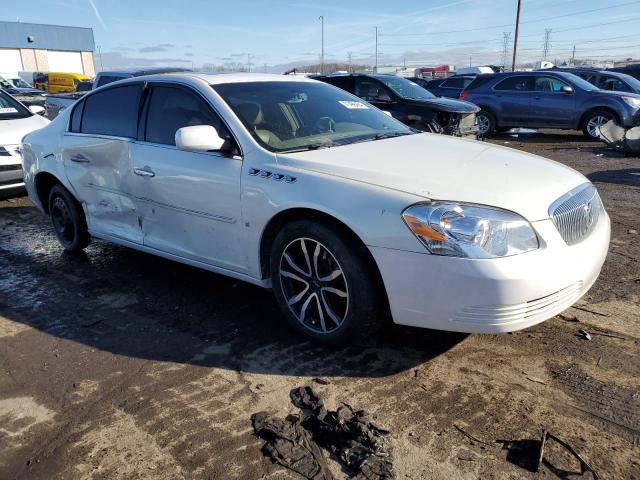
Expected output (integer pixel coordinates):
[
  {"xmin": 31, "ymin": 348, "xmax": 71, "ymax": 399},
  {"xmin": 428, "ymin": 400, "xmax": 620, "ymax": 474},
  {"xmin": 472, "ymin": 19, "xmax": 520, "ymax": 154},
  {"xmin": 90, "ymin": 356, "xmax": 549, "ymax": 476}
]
[{"xmin": 131, "ymin": 84, "xmax": 247, "ymax": 272}]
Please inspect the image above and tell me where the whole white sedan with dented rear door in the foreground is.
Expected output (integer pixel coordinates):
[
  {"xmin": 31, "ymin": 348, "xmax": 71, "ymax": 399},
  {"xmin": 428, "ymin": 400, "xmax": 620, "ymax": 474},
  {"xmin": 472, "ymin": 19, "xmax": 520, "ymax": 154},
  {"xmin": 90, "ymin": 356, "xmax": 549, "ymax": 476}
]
[{"xmin": 22, "ymin": 73, "xmax": 610, "ymax": 344}]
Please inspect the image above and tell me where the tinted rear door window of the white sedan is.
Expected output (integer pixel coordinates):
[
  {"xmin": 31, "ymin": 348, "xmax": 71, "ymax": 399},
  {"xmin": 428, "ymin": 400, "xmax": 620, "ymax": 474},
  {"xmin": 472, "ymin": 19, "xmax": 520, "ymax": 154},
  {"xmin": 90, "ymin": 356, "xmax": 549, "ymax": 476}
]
[{"xmin": 80, "ymin": 84, "xmax": 142, "ymax": 138}]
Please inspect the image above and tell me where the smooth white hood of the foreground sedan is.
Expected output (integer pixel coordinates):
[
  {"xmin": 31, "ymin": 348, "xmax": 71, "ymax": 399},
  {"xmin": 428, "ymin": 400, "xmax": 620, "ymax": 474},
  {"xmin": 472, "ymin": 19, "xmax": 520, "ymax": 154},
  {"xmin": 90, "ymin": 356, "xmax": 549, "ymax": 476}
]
[{"xmin": 278, "ymin": 133, "xmax": 588, "ymax": 221}]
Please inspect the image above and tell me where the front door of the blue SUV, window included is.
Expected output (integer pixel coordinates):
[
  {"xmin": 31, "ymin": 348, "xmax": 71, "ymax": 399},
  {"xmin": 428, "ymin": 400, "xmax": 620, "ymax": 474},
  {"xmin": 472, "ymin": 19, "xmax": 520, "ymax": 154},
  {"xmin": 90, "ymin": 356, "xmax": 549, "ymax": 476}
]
[{"xmin": 529, "ymin": 75, "xmax": 576, "ymax": 128}]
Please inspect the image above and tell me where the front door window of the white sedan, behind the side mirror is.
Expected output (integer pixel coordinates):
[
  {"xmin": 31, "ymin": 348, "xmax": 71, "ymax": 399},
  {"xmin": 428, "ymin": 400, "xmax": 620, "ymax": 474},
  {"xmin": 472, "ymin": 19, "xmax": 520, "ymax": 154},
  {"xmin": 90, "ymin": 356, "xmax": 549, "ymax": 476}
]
[{"xmin": 144, "ymin": 86, "xmax": 229, "ymax": 145}]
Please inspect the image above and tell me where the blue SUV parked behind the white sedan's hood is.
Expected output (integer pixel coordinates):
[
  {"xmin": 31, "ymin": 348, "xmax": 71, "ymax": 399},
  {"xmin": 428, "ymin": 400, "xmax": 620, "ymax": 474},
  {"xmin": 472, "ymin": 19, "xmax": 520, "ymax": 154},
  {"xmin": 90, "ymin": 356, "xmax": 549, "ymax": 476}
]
[{"xmin": 460, "ymin": 72, "xmax": 640, "ymax": 139}]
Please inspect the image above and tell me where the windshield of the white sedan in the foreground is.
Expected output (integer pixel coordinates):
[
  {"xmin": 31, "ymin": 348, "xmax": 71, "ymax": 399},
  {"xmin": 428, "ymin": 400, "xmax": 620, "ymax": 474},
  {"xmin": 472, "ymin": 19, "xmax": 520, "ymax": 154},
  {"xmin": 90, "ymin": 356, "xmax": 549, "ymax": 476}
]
[{"xmin": 211, "ymin": 81, "xmax": 413, "ymax": 153}]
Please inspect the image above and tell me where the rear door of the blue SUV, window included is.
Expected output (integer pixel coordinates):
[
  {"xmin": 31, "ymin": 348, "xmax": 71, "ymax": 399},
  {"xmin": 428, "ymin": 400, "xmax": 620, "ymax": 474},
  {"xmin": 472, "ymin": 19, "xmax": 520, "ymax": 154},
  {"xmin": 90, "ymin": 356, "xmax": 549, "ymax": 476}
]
[{"xmin": 493, "ymin": 75, "xmax": 533, "ymax": 127}]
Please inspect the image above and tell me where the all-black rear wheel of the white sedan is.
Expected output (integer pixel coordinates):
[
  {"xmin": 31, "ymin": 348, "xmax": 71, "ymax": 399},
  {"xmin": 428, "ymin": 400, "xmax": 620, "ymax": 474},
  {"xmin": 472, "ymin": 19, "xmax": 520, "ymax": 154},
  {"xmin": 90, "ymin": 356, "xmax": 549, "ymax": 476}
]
[{"xmin": 49, "ymin": 185, "xmax": 91, "ymax": 253}]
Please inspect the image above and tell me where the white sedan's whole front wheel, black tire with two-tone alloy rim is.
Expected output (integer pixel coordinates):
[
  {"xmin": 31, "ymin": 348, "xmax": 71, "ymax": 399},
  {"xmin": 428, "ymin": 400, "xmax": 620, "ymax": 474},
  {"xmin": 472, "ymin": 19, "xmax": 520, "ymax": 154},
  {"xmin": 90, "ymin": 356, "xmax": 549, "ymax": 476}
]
[{"xmin": 270, "ymin": 220, "xmax": 386, "ymax": 346}]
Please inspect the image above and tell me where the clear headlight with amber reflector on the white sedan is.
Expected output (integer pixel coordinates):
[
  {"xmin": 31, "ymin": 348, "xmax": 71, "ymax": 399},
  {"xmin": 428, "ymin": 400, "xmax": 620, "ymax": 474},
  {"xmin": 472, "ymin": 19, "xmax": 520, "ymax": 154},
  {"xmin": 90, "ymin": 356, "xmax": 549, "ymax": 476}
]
[{"xmin": 402, "ymin": 202, "xmax": 539, "ymax": 258}]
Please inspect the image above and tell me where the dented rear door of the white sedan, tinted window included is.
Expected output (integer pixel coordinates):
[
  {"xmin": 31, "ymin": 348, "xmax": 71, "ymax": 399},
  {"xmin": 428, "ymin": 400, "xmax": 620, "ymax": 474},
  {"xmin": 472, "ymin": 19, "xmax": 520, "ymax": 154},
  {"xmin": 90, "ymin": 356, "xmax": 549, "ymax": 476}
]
[{"xmin": 61, "ymin": 83, "xmax": 143, "ymax": 243}]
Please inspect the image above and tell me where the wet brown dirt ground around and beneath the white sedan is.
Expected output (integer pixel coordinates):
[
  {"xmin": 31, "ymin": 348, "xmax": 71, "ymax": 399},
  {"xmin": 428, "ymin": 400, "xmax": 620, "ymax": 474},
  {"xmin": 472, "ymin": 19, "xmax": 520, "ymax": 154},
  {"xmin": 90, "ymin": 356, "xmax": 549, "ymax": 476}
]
[{"xmin": 0, "ymin": 129, "xmax": 640, "ymax": 479}]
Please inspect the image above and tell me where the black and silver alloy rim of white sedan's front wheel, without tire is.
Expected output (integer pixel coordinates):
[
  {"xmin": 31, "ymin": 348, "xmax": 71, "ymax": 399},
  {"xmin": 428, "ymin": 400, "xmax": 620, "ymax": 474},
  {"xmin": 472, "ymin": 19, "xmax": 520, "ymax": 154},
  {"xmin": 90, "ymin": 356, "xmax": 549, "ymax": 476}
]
[{"xmin": 279, "ymin": 238, "xmax": 349, "ymax": 334}]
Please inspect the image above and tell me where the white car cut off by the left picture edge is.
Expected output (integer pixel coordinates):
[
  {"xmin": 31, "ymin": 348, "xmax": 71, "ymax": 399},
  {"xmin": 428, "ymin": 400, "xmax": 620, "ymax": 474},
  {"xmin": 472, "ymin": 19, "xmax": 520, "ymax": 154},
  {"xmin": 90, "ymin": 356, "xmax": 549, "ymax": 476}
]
[{"xmin": 0, "ymin": 92, "xmax": 49, "ymax": 199}]
